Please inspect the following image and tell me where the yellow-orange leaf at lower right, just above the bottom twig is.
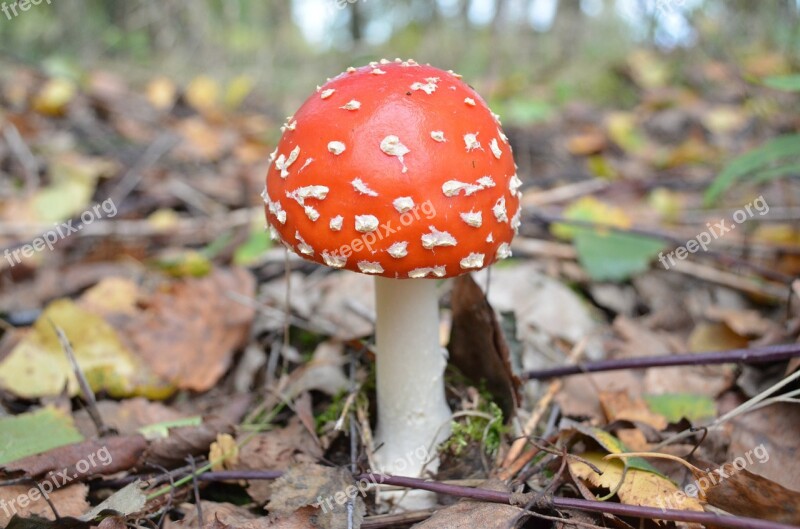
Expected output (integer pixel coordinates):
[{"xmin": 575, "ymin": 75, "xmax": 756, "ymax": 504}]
[{"xmin": 568, "ymin": 452, "xmax": 703, "ymax": 512}]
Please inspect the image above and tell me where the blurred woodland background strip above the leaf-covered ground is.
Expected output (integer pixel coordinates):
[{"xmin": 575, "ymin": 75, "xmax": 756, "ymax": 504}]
[{"xmin": 0, "ymin": 0, "xmax": 800, "ymax": 121}]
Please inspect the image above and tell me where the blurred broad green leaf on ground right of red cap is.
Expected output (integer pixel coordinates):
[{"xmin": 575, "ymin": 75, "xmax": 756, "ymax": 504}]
[{"xmin": 575, "ymin": 229, "xmax": 665, "ymax": 281}]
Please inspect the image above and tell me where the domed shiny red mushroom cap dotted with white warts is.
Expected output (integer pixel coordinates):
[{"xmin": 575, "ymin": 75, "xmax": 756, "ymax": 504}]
[{"xmin": 264, "ymin": 59, "xmax": 521, "ymax": 278}]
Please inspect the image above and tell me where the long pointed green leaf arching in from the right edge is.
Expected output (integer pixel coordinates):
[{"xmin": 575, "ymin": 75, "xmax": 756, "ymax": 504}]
[{"xmin": 703, "ymin": 134, "xmax": 800, "ymax": 206}]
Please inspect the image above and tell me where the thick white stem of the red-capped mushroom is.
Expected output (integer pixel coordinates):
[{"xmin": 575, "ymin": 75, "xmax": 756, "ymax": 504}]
[{"xmin": 375, "ymin": 277, "xmax": 452, "ymax": 509}]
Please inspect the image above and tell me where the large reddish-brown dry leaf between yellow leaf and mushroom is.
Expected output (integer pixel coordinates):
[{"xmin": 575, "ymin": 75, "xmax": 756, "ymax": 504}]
[{"xmin": 122, "ymin": 268, "xmax": 255, "ymax": 391}]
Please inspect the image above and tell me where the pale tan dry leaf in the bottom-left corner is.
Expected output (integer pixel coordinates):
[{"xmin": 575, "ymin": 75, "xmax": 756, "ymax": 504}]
[{"xmin": 0, "ymin": 483, "xmax": 89, "ymax": 527}]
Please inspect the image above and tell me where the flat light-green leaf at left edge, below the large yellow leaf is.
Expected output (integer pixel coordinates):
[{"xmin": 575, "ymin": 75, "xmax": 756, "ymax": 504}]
[{"xmin": 0, "ymin": 406, "xmax": 83, "ymax": 465}]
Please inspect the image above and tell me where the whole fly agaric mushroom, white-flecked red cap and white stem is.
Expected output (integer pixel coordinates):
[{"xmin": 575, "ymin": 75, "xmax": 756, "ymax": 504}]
[{"xmin": 263, "ymin": 59, "xmax": 521, "ymax": 507}]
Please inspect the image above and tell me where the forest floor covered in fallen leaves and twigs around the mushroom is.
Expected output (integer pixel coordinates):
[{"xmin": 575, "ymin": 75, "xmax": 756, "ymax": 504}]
[{"xmin": 0, "ymin": 47, "xmax": 800, "ymax": 529}]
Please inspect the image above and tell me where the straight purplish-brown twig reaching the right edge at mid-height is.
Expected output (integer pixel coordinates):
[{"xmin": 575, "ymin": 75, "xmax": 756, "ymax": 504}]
[{"xmin": 519, "ymin": 344, "xmax": 800, "ymax": 380}]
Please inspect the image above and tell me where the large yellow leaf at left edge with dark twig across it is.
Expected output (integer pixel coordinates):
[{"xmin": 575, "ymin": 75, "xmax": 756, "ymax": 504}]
[{"xmin": 0, "ymin": 299, "xmax": 171, "ymax": 398}]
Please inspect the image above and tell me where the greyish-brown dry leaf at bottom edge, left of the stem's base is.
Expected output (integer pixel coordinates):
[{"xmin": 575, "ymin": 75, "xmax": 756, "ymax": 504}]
[{"xmin": 266, "ymin": 463, "xmax": 366, "ymax": 529}]
